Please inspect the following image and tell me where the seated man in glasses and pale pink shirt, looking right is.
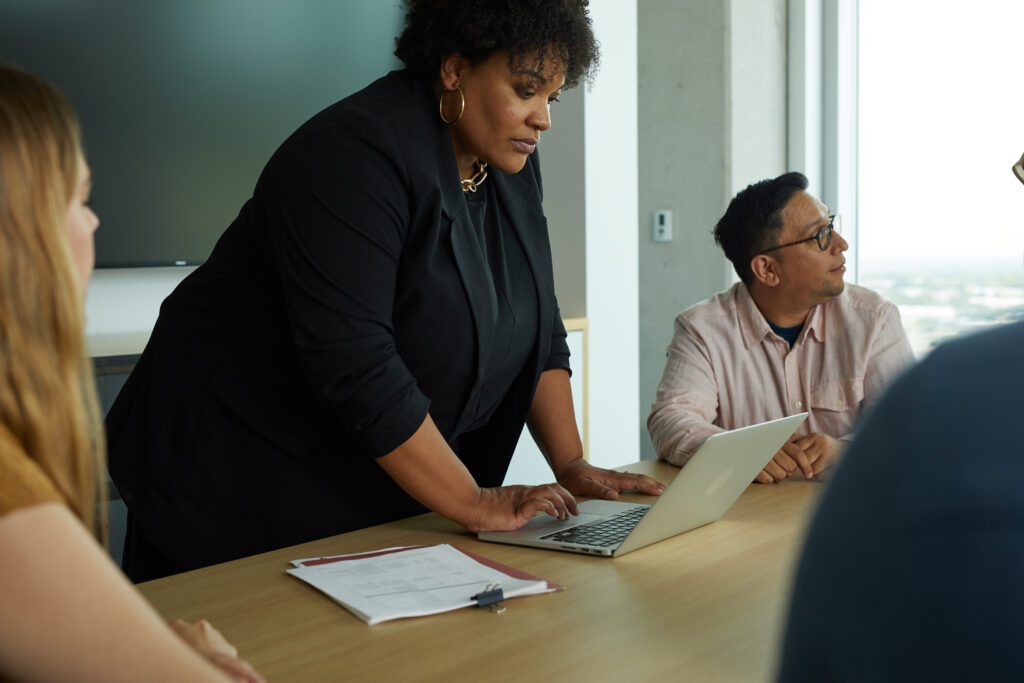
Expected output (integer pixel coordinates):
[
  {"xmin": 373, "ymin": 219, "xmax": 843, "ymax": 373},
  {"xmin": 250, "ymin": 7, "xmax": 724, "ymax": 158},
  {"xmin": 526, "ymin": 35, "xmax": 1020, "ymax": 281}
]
[{"xmin": 647, "ymin": 173, "xmax": 913, "ymax": 483}]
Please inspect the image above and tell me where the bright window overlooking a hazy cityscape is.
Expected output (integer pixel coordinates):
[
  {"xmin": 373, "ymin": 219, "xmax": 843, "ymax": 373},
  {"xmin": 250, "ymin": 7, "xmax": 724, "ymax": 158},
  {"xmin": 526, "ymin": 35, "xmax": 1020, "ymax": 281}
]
[{"xmin": 856, "ymin": 0, "xmax": 1024, "ymax": 357}]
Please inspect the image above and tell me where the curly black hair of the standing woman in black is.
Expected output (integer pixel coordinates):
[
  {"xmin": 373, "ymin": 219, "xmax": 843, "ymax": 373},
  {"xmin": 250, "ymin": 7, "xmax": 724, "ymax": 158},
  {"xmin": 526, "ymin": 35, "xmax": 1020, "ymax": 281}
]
[{"xmin": 394, "ymin": 0, "xmax": 600, "ymax": 88}]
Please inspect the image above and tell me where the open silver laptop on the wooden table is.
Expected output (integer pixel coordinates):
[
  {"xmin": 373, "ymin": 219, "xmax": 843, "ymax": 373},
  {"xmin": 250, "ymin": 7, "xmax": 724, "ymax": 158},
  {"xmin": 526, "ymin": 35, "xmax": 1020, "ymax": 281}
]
[{"xmin": 477, "ymin": 413, "xmax": 807, "ymax": 557}]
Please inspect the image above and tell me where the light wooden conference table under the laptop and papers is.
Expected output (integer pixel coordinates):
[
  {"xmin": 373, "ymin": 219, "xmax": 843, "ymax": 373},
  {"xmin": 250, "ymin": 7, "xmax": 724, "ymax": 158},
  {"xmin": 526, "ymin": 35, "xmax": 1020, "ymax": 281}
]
[{"xmin": 139, "ymin": 462, "xmax": 821, "ymax": 683}]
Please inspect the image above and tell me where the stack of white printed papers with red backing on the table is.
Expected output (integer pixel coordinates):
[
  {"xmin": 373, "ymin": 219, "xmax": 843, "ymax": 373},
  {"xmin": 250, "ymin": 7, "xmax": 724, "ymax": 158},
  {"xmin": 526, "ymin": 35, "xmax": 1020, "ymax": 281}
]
[{"xmin": 288, "ymin": 545, "xmax": 563, "ymax": 624}]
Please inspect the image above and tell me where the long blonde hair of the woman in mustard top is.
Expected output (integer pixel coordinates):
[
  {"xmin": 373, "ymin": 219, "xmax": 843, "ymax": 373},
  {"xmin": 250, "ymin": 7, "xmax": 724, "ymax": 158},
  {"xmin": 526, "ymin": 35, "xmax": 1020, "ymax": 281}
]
[{"xmin": 0, "ymin": 63, "xmax": 105, "ymax": 541}]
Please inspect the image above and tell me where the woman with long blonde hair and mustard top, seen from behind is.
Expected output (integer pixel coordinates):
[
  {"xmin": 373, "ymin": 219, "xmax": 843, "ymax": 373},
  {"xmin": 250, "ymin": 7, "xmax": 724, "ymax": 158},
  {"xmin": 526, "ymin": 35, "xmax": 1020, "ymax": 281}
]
[{"xmin": 0, "ymin": 65, "xmax": 261, "ymax": 681}]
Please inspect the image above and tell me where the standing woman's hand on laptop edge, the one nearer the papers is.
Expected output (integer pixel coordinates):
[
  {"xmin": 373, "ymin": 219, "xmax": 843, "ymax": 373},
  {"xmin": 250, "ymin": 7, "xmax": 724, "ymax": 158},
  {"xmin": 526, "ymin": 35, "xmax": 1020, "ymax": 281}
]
[{"xmin": 465, "ymin": 483, "xmax": 579, "ymax": 532}]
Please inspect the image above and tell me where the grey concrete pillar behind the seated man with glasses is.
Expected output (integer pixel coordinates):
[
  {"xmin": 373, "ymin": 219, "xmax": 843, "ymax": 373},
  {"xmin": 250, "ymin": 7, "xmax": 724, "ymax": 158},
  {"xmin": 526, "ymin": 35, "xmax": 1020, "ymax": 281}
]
[{"xmin": 637, "ymin": 0, "xmax": 786, "ymax": 458}]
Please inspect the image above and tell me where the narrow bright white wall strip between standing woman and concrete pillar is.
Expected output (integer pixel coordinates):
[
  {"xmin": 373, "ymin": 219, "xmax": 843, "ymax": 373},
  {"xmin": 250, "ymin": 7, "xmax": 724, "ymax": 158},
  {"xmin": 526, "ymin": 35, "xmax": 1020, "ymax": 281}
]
[{"xmin": 584, "ymin": 0, "xmax": 640, "ymax": 466}]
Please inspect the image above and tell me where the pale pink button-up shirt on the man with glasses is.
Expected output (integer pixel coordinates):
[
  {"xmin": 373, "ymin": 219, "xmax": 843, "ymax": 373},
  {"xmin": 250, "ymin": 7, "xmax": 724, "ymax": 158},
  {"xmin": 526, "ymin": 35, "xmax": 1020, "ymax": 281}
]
[{"xmin": 647, "ymin": 283, "xmax": 913, "ymax": 465}]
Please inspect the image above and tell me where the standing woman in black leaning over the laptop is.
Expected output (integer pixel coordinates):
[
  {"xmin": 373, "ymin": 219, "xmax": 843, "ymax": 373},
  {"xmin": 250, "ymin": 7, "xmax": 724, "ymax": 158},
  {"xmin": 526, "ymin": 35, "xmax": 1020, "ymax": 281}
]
[{"xmin": 108, "ymin": 0, "xmax": 662, "ymax": 581}]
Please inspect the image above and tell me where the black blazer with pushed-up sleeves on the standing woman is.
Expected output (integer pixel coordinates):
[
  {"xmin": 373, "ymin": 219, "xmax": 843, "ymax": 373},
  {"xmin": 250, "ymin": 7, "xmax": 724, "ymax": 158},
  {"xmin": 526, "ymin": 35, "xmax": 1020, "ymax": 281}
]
[{"xmin": 106, "ymin": 72, "xmax": 568, "ymax": 569}]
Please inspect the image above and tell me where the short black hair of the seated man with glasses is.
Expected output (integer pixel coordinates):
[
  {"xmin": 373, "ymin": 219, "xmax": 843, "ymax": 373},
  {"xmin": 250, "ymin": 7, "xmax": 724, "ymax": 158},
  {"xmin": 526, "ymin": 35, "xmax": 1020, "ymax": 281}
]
[{"xmin": 715, "ymin": 171, "xmax": 807, "ymax": 287}]
